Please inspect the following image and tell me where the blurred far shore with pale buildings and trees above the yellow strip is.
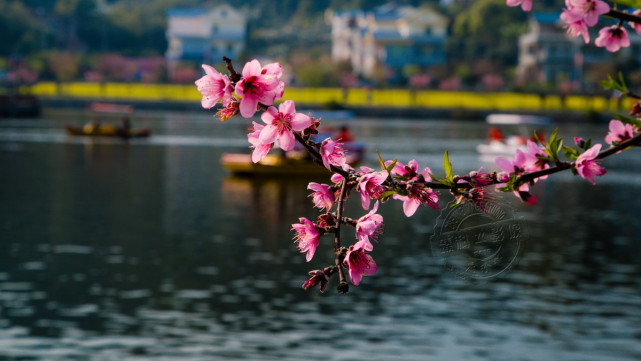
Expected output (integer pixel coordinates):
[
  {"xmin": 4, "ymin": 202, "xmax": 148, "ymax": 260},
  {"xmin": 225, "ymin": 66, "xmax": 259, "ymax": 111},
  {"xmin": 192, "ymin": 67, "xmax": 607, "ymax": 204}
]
[{"xmin": 0, "ymin": 0, "xmax": 641, "ymax": 98}]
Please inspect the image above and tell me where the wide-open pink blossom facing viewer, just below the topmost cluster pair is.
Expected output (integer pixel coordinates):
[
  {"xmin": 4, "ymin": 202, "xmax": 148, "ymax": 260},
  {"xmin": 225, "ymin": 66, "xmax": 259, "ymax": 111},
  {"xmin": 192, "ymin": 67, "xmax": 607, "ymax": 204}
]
[{"xmin": 258, "ymin": 100, "xmax": 312, "ymax": 151}]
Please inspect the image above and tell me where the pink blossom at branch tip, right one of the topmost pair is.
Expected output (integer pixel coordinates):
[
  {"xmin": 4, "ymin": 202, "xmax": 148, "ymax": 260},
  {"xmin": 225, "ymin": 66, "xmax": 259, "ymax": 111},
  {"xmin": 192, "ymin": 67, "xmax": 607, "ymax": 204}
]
[{"xmin": 235, "ymin": 59, "xmax": 284, "ymax": 118}]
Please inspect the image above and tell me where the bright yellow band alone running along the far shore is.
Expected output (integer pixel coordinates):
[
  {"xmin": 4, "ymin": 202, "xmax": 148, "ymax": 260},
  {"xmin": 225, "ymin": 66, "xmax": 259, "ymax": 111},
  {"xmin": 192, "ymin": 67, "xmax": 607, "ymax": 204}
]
[{"xmin": 30, "ymin": 82, "xmax": 631, "ymax": 111}]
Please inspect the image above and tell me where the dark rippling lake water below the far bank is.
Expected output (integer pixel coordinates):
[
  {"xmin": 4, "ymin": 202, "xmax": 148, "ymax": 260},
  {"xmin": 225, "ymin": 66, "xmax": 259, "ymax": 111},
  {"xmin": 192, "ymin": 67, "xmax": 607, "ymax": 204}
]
[{"xmin": 0, "ymin": 111, "xmax": 641, "ymax": 361}]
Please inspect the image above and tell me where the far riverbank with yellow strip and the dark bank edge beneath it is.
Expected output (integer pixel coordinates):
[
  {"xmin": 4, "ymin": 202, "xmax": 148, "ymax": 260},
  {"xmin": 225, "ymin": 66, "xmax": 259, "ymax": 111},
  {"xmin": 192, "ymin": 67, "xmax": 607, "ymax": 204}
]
[{"xmin": 26, "ymin": 82, "xmax": 632, "ymax": 122}]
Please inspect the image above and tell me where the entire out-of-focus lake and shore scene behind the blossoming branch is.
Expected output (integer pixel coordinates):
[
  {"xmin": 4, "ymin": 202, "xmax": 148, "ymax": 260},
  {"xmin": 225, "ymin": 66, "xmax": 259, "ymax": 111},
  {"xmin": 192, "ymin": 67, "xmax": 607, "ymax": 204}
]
[{"xmin": 0, "ymin": 0, "xmax": 641, "ymax": 361}]
